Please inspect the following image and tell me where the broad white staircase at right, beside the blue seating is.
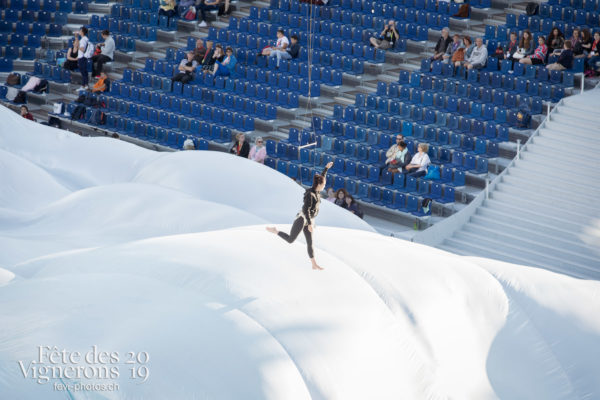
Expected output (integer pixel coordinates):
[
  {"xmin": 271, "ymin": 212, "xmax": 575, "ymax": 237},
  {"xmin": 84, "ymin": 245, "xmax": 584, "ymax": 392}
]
[{"xmin": 439, "ymin": 89, "xmax": 600, "ymax": 279}]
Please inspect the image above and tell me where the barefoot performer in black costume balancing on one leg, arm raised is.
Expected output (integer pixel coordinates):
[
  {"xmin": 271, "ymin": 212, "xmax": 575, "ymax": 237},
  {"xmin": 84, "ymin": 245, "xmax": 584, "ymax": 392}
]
[{"xmin": 267, "ymin": 161, "xmax": 333, "ymax": 270}]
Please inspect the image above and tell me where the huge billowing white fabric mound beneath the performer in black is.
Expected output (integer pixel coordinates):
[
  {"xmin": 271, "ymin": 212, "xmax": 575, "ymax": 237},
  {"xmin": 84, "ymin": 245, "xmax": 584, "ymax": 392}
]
[{"xmin": 0, "ymin": 107, "xmax": 600, "ymax": 400}]
